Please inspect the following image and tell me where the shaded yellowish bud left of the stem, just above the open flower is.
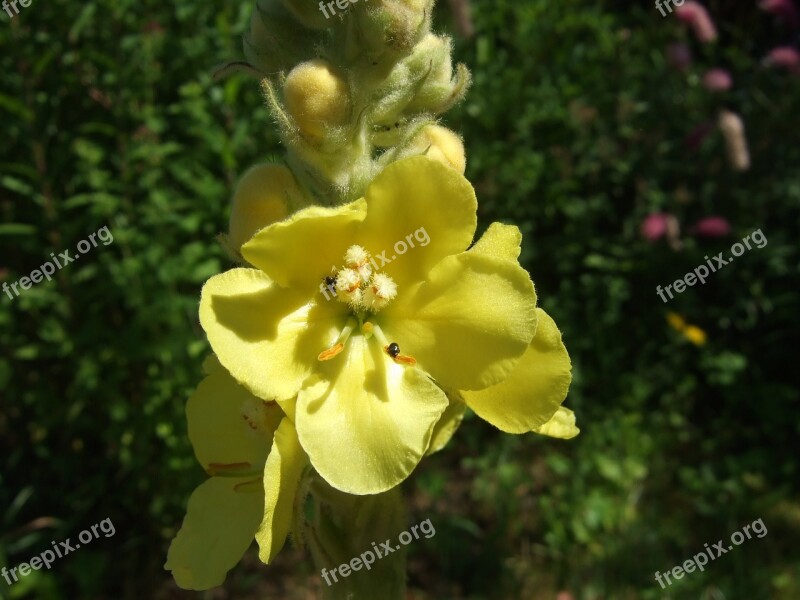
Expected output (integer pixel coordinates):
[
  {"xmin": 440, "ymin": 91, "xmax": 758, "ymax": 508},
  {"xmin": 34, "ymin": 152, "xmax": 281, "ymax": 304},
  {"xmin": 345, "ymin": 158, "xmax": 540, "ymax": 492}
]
[{"xmin": 228, "ymin": 164, "xmax": 302, "ymax": 252}]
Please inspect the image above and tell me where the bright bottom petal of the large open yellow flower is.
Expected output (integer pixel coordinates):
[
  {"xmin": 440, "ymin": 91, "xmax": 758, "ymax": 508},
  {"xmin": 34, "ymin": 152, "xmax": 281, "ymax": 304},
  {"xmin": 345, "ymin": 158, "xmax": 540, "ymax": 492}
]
[{"xmin": 296, "ymin": 334, "xmax": 447, "ymax": 494}]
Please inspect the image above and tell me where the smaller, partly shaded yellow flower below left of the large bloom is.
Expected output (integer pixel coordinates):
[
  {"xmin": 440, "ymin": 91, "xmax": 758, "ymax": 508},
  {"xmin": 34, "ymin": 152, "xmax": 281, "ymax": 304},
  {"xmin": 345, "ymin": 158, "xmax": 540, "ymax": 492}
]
[{"xmin": 164, "ymin": 357, "xmax": 308, "ymax": 590}]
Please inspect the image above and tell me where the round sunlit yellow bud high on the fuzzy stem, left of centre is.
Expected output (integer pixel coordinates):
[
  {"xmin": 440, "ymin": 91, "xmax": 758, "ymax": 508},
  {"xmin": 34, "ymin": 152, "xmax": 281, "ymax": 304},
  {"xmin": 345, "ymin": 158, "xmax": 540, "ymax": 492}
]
[{"xmin": 283, "ymin": 58, "xmax": 351, "ymax": 138}]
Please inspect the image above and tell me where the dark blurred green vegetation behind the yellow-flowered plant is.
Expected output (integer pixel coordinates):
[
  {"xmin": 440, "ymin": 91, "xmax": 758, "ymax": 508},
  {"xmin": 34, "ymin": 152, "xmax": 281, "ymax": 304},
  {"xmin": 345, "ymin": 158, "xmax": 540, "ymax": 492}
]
[{"xmin": 0, "ymin": 0, "xmax": 800, "ymax": 600}]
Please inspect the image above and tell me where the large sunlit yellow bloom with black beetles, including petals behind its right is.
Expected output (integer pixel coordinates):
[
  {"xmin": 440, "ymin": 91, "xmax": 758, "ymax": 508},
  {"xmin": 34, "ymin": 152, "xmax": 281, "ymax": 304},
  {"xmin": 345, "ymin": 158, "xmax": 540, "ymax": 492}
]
[{"xmin": 200, "ymin": 157, "xmax": 577, "ymax": 494}]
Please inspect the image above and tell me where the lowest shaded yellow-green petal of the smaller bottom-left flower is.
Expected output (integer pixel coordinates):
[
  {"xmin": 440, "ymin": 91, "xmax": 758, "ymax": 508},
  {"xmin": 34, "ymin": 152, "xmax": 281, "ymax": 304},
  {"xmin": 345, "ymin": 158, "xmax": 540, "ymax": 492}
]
[{"xmin": 164, "ymin": 477, "xmax": 264, "ymax": 590}]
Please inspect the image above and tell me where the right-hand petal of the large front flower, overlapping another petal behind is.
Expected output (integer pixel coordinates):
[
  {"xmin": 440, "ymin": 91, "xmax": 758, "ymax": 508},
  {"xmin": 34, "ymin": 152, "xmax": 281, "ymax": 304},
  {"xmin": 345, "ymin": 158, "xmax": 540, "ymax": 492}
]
[{"xmin": 380, "ymin": 252, "xmax": 536, "ymax": 390}]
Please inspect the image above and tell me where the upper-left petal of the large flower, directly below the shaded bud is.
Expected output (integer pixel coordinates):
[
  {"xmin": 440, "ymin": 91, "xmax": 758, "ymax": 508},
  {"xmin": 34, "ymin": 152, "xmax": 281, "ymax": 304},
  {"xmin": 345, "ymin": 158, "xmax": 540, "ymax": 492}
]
[{"xmin": 242, "ymin": 200, "xmax": 366, "ymax": 297}]
